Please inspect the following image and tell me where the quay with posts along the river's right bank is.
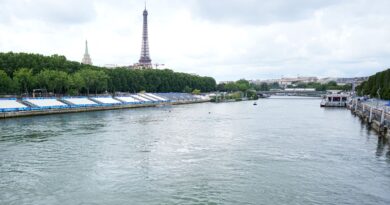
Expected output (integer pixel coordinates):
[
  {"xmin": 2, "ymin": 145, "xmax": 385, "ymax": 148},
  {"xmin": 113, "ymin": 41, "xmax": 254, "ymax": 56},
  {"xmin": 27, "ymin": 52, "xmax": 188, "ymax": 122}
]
[{"xmin": 347, "ymin": 99, "xmax": 390, "ymax": 139}]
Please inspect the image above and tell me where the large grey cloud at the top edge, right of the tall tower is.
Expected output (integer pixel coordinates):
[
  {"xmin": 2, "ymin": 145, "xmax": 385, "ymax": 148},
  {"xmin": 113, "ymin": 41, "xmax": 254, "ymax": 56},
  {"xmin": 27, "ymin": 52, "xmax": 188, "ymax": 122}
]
[{"xmin": 194, "ymin": 0, "xmax": 343, "ymax": 25}]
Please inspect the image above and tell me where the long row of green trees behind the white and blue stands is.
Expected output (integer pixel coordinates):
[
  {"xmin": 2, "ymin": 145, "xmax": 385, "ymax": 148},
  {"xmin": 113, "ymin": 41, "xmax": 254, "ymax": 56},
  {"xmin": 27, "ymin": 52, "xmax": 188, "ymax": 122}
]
[{"xmin": 0, "ymin": 52, "xmax": 216, "ymax": 95}]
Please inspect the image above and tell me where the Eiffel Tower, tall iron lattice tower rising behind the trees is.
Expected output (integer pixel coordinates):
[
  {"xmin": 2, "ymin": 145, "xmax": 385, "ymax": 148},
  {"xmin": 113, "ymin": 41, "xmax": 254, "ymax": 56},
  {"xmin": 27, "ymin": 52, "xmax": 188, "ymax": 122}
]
[{"xmin": 138, "ymin": 4, "xmax": 152, "ymax": 68}]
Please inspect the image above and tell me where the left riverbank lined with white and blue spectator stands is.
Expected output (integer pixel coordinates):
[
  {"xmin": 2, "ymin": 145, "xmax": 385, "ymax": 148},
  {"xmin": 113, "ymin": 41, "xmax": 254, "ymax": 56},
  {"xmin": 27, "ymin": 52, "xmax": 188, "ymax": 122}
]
[{"xmin": 0, "ymin": 93, "xmax": 210, "ymax": 119}]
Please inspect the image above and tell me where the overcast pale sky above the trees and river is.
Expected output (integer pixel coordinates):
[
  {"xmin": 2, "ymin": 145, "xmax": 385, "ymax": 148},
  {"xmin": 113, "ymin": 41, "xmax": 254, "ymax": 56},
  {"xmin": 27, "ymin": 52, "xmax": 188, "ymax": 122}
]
[{"xmin": 0, "ymin": 0, "xmax": 390, "ymax": 81}]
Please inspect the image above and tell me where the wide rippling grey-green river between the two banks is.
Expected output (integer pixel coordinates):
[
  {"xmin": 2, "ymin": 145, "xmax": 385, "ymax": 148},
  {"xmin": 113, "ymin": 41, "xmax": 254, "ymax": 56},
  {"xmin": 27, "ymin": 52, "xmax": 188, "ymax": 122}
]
[{"xmin": 0, "ymin": 98, "xmax": 390, "ymax": 205}]
